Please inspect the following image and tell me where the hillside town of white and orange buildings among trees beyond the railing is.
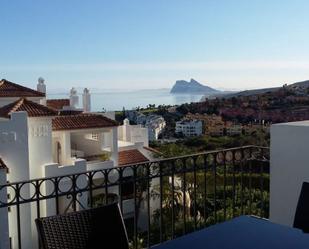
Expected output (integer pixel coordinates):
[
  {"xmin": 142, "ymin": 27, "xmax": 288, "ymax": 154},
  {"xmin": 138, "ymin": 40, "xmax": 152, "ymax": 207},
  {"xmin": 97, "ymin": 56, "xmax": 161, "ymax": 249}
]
[{"xmin": 116, "ymin": 80, "xmax": 309, "ymax": 156}]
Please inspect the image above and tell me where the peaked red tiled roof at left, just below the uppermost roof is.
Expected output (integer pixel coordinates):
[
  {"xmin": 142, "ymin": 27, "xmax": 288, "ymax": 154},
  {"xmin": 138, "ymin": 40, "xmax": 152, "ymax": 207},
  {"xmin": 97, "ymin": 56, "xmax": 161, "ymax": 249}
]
[{"xmin": 0, "ymin": 98, "xmax": 57, "ymax": 118}]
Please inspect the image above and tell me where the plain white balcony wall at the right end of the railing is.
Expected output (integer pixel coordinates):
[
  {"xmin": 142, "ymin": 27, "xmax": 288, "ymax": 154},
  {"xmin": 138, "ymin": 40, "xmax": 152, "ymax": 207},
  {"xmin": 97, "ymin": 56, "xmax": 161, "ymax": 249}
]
[{"xmin": 270, "ymin": 121, "xmax": 309, "ymax": 226}]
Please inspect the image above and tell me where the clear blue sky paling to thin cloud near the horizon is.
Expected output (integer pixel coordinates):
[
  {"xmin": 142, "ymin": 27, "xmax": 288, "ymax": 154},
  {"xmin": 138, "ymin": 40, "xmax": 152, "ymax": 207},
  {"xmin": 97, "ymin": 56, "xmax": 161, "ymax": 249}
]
[{"xmin": 0, "ymin": 0, "xmax": 309, "ymax": 90}]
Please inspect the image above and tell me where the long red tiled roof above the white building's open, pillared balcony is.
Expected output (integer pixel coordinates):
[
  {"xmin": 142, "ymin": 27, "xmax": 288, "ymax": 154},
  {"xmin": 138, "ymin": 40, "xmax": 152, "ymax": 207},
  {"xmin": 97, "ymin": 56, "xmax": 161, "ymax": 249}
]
[{"xmin": 53, "ymin": 113, "xmax": 118, "ymax": 131}]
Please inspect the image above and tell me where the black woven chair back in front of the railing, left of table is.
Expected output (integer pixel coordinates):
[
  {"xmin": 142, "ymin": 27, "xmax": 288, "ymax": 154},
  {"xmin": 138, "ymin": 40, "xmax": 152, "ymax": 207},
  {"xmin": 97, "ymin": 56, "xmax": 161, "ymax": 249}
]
[{"xmin": 35, "ymin": 203, "xmax": 129, "ymax": 249}]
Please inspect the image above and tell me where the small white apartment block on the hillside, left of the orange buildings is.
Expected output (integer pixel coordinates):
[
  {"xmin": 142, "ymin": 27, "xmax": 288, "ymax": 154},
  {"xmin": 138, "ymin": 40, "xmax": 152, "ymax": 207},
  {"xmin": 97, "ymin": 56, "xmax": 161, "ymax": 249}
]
[{"xmin": 175, "ymin": 120, "xmax": 203, "ymax": 137}]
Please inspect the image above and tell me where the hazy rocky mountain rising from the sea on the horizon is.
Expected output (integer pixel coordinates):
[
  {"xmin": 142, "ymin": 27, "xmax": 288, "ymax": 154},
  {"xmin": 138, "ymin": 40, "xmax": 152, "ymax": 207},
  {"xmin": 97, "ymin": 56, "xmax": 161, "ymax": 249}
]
[{"xmin": 170, "ymin": 79, "xmax": 220, "ymax": 94}]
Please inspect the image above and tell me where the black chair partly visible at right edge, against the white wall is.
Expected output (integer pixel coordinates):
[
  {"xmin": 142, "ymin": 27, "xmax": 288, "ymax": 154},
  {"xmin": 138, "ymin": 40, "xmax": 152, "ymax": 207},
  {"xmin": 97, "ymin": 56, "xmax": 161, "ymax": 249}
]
[{"xmin": 293, "ymin": 182, "xmax": 309, "ymax": 233}]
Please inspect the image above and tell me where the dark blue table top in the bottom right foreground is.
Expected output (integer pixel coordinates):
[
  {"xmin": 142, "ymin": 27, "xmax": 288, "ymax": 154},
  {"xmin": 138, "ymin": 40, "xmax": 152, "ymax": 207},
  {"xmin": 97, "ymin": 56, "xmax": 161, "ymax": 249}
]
[{"xmin": 153, "ymin": 216, "xmax": 309, "ymax": 249}]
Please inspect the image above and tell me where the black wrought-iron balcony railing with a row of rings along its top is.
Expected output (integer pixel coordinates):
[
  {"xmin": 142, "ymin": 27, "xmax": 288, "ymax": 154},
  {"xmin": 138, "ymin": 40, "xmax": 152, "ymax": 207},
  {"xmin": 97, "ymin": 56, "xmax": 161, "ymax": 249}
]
[{"xmin": 0, "ymin": 146, "xmax": 269, "ymax": 248}]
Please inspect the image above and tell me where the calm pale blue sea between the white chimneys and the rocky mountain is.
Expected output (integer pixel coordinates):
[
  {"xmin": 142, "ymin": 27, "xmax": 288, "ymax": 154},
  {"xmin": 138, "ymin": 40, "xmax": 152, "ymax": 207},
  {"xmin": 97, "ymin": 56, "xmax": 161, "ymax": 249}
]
[{"xmin": 47, "ymin": 89, "xmax": 203, "ymax": 111}]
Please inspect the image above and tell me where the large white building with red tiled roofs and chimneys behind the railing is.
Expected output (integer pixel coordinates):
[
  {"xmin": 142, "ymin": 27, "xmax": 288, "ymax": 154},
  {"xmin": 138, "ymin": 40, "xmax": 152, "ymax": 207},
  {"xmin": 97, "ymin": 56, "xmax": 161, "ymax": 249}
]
[{"xmin": 0, "ymin": 79, "xmax": 151, "ymax": 249}]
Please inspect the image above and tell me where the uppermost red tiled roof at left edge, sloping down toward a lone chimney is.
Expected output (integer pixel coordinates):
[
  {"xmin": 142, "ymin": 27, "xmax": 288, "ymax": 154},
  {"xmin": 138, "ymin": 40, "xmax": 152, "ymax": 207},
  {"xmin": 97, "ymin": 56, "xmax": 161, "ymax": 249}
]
[{"xmin": 0, "ymin": 79, "xmax": 45, "ymax": 97}]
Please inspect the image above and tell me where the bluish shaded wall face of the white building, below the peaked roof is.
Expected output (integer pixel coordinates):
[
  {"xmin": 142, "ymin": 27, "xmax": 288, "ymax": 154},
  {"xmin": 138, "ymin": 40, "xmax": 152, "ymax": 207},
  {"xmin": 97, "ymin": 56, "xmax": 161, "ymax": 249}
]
[{"xmin": 0, "ymin": 112, "xmax": 31, "ymax": 248}]
